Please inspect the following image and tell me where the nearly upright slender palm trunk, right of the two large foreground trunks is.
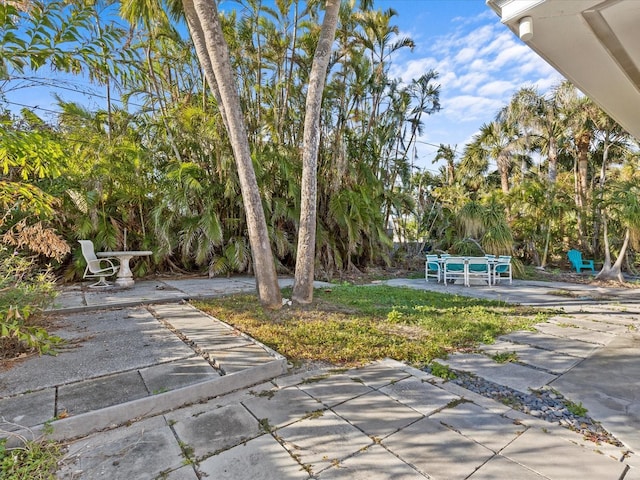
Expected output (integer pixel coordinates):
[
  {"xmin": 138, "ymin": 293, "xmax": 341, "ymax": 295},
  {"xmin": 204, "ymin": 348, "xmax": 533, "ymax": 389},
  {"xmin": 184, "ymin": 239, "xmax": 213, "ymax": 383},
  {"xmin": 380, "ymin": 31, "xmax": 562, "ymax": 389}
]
[{"xmin": 293, "ymin": 0, "xmax": 340, "ymax": 303}]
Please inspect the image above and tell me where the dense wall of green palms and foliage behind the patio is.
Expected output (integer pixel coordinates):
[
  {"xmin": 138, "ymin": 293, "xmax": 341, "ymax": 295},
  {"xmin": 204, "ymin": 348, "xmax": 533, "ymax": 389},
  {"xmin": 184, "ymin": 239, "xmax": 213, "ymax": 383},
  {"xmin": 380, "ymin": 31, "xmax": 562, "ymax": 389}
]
[{"xmin": 0, "ymin": 0, "xmax": 640, "ymax": 279}]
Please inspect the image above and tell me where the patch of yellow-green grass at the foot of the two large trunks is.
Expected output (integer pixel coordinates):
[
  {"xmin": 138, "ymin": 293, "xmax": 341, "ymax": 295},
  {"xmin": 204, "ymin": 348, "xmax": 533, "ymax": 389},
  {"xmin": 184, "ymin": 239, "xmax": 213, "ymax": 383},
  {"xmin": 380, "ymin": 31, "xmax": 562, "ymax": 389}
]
[{"xmin": 194, "ymin": 285, "xmax": 541, "ymax": 366}]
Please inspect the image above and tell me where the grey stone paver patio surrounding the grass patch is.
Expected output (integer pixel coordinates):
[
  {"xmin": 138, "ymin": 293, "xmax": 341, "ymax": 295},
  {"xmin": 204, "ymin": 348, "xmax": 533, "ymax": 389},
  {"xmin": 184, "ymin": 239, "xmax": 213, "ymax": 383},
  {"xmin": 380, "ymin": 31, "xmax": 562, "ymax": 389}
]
[{"xmin": 0, "ymin": 278, "xmax": 640, "ymax": 480}]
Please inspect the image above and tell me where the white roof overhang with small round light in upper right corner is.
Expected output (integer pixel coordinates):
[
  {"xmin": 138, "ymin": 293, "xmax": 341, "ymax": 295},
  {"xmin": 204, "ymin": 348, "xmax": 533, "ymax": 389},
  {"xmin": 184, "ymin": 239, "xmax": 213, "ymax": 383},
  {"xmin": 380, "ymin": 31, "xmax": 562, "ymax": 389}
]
[{"xmin": 486, "ymin": 0, "xmax": 640, "ymax": 139}]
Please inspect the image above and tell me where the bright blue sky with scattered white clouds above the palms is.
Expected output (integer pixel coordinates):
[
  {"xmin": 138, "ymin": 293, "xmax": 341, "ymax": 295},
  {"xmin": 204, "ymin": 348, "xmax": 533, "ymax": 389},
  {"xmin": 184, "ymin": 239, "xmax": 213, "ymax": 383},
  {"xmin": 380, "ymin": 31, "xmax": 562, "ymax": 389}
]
[{"xmin": 7, "ymin": 0, "xmax": 563, "ymax": 172}]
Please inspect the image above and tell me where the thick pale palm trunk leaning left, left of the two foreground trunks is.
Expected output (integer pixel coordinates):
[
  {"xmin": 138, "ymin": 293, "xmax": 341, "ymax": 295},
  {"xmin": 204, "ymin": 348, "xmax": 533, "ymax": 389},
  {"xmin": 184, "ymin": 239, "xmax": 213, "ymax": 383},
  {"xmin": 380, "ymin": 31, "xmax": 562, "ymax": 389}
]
[{"xmin": 182, "ymin": 0, "xmax": 282, "ymax": 308}]
